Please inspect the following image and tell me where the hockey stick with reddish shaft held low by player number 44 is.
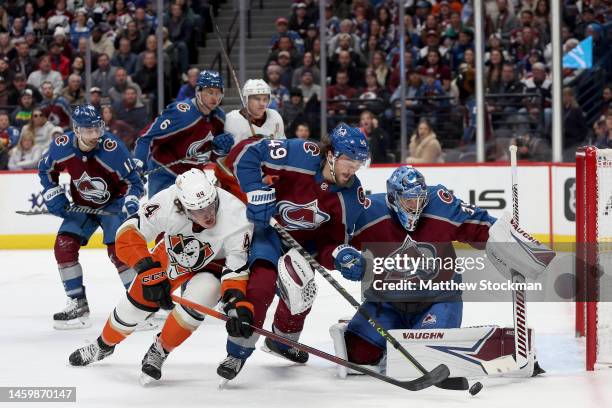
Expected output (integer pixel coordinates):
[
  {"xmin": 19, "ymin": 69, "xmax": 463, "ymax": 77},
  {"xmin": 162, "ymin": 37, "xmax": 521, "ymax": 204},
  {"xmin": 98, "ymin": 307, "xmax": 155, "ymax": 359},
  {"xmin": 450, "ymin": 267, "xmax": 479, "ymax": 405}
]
[{"xmin": 172, "ymin": 295, "xmax": 436, "ymax": 391}]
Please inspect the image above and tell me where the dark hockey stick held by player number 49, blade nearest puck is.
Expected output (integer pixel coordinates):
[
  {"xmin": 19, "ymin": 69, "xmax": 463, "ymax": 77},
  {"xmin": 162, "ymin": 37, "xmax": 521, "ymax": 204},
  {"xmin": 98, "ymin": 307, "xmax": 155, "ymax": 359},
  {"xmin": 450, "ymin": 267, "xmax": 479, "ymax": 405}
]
[{"xmin": 270, "ymin": 218, "xmax": 468, "ymax": 390}]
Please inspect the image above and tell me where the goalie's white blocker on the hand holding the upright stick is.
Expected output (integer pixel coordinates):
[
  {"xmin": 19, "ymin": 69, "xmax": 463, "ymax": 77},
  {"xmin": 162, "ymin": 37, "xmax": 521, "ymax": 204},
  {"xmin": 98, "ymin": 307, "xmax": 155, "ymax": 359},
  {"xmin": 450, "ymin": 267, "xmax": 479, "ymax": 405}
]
[{"xmin": 486, "ymin": 212, "xmax": 555, "ymax": 281}]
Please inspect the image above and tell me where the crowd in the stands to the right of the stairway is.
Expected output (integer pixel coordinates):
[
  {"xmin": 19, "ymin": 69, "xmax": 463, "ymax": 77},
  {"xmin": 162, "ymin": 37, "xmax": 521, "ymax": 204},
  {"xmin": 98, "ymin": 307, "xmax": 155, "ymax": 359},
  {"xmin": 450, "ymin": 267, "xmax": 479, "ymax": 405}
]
[{"xmin": 263, "ymin": 0, "xmax": 612, "ymax": 163}]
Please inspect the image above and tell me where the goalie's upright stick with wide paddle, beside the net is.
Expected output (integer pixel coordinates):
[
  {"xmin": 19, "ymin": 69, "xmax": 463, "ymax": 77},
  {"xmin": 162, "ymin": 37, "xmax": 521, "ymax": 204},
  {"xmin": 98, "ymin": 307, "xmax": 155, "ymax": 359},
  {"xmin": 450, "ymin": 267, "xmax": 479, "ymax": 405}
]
[{"xmin": 510, "ymin": 146, "xmax": 529, "ymax": 368}]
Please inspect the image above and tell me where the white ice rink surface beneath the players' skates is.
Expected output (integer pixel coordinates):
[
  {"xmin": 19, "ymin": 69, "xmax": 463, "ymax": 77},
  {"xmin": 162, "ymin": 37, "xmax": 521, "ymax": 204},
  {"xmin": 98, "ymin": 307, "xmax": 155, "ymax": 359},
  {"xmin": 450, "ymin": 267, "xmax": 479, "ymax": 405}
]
[{"xmin": 0, "ymin": 250, "xmax": 612, "ymax": 408}]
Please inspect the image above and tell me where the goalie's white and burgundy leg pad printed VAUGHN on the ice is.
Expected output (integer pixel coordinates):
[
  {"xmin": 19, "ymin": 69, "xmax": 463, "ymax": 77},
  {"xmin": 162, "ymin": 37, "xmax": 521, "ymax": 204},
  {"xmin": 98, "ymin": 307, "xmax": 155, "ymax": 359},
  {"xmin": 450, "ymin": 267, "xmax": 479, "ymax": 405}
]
[{"xmin": 387, "ymin": 326, "xmax": 535, "ymax": 379}]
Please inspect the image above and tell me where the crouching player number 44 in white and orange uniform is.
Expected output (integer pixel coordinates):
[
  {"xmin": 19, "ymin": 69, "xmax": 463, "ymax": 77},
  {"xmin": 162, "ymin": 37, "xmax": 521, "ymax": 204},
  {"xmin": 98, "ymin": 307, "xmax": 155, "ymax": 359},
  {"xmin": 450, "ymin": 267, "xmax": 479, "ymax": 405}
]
[{"xmin": 69, "ymin": 169, "xmax": 253, "ymax": 383}]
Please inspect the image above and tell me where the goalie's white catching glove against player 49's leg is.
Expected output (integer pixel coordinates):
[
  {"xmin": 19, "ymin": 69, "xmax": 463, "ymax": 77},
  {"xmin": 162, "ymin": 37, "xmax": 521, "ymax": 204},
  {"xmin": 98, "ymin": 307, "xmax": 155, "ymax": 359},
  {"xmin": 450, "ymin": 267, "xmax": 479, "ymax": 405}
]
[{"xmin": 277, "ymin": 248, "xmax": 317, "ymax": 315}]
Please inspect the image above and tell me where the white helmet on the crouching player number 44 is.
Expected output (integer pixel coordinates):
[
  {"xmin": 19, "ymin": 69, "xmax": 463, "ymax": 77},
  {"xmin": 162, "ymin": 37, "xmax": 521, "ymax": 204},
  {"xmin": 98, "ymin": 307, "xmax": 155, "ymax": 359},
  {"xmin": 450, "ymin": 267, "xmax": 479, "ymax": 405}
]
[{"xmin": 175, "ymin": 169, "xmax": 218, "ymax": 210}]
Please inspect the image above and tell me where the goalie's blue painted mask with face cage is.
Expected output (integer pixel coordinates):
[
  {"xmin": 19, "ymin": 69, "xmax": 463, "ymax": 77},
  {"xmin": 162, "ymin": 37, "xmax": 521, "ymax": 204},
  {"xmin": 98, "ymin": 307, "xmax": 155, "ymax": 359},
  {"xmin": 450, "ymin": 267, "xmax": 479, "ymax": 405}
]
[{"xmin": 386, "ymin": 166, "xmax": 429, "ymax": 231}]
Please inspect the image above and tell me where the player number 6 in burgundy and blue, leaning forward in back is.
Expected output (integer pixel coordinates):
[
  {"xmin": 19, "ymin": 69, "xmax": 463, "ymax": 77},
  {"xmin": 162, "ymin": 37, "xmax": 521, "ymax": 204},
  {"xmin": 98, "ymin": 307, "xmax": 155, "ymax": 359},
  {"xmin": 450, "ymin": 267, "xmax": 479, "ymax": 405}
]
[{"xmin": 134, "ymin": 70, "xmax": 234, "ymax": 197}]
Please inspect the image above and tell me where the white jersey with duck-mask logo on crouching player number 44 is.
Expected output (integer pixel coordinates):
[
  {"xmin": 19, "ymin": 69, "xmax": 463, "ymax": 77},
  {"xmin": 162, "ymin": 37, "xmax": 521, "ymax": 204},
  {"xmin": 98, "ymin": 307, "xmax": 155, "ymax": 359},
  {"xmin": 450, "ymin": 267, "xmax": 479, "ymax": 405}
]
[{"xmin": 126, "ymin": 185, "xmax": 253, "ymax": 281}]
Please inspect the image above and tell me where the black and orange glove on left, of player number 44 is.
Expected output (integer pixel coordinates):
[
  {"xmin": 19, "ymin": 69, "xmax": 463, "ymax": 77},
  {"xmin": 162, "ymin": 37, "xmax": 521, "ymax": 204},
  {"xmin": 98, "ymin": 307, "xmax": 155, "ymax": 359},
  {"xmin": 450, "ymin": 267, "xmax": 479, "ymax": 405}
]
[{"xmin": 134, "ymin": 257, "xmax": 174, "ymax": 310}]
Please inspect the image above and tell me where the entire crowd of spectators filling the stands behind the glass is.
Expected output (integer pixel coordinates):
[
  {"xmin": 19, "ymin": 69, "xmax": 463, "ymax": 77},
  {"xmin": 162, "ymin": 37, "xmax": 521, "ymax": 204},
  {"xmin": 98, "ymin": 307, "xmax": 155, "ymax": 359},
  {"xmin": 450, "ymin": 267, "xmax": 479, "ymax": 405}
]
[{"xmin": 0, "ymin": 0, "xmax": 612, "ymax": 169}]
